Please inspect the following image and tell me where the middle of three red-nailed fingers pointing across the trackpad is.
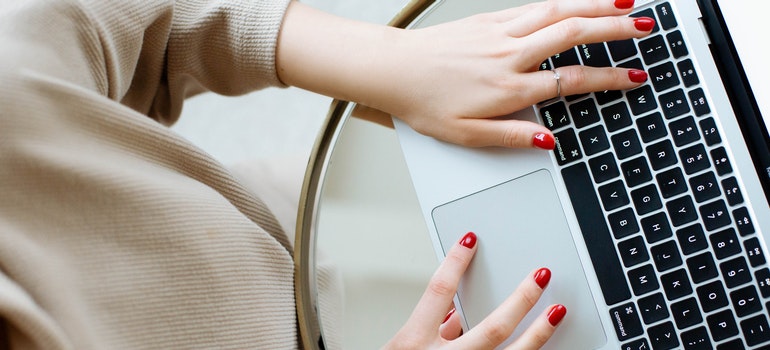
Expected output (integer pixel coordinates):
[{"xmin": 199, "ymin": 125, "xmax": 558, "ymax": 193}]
[{"xmin": 458, "ymin": 268, "xmax": 551, "ymax": 348}]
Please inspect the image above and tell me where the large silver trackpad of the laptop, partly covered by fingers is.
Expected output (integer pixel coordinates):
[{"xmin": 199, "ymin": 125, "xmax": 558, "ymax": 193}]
[{"xmin": 433, "ymin": 169, "xmax": 607, "ymax": 349}]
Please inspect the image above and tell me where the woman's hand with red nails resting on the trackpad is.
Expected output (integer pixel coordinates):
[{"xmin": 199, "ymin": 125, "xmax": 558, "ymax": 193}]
[{"xmin": 385, "ymin": 232, "xmax": 567, "ymax": 349}]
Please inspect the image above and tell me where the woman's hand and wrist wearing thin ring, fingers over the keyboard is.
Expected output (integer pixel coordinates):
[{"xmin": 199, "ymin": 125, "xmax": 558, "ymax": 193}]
[{"xmin": 278, "ymin": 0, "xmax": 654, "ymax": 147}]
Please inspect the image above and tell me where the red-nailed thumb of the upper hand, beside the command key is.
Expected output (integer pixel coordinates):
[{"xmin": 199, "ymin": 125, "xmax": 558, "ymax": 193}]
[{"xmin": 443, "ymin": 118, "xmax": 555, "ymax": 150}]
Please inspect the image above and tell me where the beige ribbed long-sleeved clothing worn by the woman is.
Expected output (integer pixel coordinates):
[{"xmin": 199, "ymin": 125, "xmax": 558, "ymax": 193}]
[{"xmin": 0, "ymin": 0, "xmax": 298, "ymax": 350}]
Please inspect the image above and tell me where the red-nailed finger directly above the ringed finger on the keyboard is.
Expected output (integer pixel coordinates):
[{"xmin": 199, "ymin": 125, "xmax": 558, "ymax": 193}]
[{"xmin": 516, "ymin": 17, "xmax": 655, "ymax": 65}]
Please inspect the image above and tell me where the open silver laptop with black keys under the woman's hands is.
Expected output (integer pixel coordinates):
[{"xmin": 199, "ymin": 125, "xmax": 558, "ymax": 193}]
[{"xmin": 395, "ymin": 0, "xmax": 770, "ymax": 349}]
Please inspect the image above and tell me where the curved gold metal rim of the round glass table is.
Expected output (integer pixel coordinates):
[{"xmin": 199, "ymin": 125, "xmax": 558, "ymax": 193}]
[{"xmin": 294, "ymin": 0, "xmax": 440, "ymax": 349}]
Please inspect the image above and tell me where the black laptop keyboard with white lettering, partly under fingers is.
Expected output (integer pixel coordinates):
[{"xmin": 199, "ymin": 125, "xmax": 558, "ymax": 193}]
[{"xmin": 538, "ymin": 3, "xmax": 770, "ymax": 350}]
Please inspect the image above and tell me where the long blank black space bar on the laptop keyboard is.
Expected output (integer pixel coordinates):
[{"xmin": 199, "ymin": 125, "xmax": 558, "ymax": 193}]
[{"xmin": 561, "ymin": 163, "xmax": 631, "ymax": 305}]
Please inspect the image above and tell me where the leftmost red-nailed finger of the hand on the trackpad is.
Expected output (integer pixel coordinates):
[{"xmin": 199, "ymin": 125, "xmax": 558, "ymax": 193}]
[{"xmin": 408, "ymin": 232, "xmax": 477, "ymax": 334}]
